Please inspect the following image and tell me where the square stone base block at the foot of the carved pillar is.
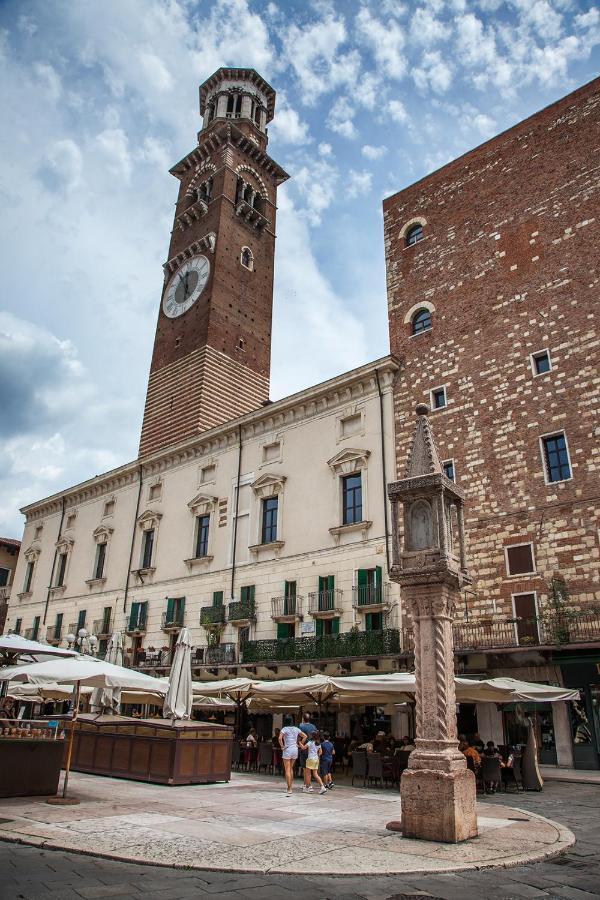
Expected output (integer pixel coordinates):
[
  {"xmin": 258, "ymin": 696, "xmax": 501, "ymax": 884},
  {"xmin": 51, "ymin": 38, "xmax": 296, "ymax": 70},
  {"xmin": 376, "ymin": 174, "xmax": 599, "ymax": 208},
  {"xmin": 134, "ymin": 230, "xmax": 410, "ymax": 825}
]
[{"xmin": 390, "ymin": 769, "xmax": 477, "ymax": 844}]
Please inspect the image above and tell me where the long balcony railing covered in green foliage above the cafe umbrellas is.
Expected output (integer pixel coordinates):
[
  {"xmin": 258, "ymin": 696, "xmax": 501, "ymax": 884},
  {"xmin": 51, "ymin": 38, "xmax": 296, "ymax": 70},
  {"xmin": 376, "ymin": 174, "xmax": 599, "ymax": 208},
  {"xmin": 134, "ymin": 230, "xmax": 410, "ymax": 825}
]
[{"xmin": 241, "ymin": 628, "xmax": 401, "ymax": 663}]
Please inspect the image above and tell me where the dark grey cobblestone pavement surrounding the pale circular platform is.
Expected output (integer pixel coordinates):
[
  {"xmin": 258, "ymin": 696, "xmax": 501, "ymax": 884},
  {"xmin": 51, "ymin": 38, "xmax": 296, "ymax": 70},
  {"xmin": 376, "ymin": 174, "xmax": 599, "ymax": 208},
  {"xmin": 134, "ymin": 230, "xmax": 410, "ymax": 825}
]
[{"xmin": 0, "ymin": 782, "xmax": 600, "ymax": 900}]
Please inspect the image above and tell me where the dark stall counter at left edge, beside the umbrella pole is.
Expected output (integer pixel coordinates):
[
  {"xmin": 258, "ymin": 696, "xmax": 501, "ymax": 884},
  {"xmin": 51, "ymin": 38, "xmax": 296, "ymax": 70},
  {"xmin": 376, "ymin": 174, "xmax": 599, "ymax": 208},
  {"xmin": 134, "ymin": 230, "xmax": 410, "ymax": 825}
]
[{"xmin": 0, "ymin": 722, "xmax": 65, "ymax": 797}]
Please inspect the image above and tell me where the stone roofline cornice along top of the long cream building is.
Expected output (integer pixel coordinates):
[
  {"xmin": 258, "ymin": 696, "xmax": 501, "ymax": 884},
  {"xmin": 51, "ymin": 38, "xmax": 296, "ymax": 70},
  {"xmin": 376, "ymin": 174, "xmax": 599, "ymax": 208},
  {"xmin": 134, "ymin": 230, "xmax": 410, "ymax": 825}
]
[{"xmin": 21, "ymin": 356, "xmax": 400, "ymax": 523}]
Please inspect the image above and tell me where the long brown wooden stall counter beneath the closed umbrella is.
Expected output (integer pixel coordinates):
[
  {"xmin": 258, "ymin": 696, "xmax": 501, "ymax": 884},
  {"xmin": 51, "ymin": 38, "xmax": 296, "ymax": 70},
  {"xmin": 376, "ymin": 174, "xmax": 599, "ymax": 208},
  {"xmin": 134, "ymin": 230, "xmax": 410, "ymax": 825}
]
[{"xmin": 65, "ymin": 715, "xmax": 233, "ymax": 784}]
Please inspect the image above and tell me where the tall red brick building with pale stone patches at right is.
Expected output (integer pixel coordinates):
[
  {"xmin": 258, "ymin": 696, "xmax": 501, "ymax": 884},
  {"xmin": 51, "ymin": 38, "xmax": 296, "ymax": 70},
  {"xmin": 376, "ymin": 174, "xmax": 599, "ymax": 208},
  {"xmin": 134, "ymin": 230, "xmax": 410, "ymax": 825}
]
[{"xmin": 384, "ymin": 79, "xmax": 600, "ymax": 765}]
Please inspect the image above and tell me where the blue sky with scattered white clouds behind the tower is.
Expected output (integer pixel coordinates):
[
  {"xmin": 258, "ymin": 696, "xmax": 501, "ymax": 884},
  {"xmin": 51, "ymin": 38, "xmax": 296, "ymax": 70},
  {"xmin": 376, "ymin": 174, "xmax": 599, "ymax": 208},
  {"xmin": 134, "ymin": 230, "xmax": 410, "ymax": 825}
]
[{"xmin": 0, "ymin": 0, "xmax": 600, "ymax": 537}]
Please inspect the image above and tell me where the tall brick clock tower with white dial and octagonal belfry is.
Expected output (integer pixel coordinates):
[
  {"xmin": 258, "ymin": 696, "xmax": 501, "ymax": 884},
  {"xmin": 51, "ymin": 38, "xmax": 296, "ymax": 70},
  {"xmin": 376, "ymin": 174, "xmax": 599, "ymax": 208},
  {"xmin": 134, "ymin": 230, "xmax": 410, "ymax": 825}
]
[{"xmin": 139, "ymin": 68, "xmax": 288, "ymax": 456}]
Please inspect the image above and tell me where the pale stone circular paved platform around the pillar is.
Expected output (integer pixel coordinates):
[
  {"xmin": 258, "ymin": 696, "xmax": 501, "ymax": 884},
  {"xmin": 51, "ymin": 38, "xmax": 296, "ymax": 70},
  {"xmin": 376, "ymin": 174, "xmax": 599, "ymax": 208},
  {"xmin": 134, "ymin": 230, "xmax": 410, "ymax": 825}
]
[{"xmin": 0, "ymin": 773, "xmax": 576, "ymax": 876}]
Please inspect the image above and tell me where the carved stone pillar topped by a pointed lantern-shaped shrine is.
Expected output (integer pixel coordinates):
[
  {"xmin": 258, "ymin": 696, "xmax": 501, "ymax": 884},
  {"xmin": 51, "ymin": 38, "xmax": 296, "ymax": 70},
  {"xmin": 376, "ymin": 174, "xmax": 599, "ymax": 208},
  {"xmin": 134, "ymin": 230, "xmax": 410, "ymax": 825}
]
[{"xmin": 388, "ymin": 404, "xmax": 477, "ymax": 842}]
